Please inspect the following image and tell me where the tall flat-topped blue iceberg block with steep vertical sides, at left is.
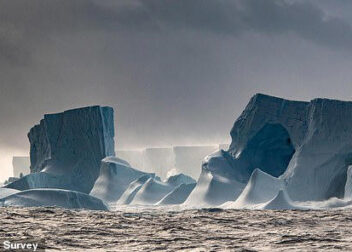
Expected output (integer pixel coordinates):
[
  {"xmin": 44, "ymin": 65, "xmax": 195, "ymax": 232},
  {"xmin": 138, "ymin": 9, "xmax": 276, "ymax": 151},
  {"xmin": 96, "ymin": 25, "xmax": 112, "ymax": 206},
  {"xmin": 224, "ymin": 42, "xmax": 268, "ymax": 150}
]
[{"xmin": 5, "ymin": 106, "xmax": 115, "ymax": 193}]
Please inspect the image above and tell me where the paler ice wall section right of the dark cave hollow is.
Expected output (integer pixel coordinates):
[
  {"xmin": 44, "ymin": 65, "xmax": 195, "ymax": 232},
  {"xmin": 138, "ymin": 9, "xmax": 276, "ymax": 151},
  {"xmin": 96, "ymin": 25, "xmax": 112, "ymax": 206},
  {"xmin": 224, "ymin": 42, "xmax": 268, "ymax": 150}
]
[{"xmin": 282, "ymin": 99, "xmax": 352, "ymax": 201}]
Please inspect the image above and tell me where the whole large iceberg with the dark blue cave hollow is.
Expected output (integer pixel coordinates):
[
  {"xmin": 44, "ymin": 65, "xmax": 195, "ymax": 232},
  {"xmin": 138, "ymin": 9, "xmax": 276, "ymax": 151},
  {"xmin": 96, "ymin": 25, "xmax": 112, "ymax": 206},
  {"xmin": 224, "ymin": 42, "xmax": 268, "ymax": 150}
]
[{"xmin": 186, "ymin": 94, "xmax": 352, "ymax": 208}]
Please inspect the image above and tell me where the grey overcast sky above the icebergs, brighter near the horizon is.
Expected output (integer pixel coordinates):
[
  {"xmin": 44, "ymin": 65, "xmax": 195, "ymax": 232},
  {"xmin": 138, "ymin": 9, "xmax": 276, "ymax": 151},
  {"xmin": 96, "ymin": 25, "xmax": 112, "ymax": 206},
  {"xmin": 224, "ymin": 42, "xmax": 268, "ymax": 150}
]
[{"xmin": 0, "ymin": 0, "xmax": 352, "ymax": 181}]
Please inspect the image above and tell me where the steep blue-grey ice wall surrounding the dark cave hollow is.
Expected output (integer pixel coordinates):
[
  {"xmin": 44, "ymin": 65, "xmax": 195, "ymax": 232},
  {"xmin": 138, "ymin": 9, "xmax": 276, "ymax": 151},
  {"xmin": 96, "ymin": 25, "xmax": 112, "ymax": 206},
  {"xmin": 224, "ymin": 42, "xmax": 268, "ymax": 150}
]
[{"xmin": 229, "ymin": 94, "xmax": 352, "ymax": 201}]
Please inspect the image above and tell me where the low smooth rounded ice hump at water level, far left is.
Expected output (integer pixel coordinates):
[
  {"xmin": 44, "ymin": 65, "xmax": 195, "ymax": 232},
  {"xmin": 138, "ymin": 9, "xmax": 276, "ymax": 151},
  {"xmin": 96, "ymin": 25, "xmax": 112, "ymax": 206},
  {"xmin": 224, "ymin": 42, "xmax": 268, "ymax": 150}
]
[{"xmin": 0, "ymin": 189, "xmax": 108, "ymax": 211}]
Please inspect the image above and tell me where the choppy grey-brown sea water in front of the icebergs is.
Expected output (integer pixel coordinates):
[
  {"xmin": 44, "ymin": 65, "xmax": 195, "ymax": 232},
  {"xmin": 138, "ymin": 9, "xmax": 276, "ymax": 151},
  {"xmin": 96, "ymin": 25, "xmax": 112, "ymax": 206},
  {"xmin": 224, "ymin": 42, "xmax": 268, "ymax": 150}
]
[{"xmin": 0, "ymin": 208, "xmax": 352, "ymax": 251}]
